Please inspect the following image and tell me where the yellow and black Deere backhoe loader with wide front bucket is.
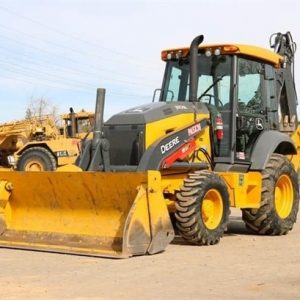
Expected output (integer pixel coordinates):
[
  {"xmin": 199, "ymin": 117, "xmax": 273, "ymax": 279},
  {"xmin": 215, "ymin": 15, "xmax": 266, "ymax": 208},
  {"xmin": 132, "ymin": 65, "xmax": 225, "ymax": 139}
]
[{"xmin": 0, "ymin": 32, "xmax": 300, "ymax": 258}]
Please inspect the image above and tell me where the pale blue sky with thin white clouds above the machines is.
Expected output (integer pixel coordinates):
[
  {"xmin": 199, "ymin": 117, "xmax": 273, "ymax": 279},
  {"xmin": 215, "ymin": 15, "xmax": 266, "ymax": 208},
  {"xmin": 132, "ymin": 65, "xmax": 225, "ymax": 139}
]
[{"xmin": 0, "ymin": 0, "xmax": 300, "ymax": 123}]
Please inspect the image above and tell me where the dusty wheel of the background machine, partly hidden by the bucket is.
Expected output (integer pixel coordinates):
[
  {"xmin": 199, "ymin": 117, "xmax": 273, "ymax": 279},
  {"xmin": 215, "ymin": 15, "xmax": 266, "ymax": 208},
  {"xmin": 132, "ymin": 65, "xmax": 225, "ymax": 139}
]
[{"xmin": 17, "ymin": 147, "xmax": 56, "ymax": 171}]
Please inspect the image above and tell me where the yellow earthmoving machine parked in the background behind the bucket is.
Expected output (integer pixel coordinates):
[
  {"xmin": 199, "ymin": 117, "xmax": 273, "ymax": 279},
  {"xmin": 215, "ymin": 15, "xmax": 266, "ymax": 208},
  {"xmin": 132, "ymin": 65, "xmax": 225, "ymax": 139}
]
[{"xmin": 0, "ymin": 109, "xmax": 94, "ymax": 171}]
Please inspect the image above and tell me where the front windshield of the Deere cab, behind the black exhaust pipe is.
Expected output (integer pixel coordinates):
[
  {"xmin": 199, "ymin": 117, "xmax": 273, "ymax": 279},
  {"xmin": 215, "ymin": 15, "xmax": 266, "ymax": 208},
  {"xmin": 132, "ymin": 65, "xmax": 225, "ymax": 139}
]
[{"xmin": 161, "ymin": 54, "xmax": 232, "ymax": 106}]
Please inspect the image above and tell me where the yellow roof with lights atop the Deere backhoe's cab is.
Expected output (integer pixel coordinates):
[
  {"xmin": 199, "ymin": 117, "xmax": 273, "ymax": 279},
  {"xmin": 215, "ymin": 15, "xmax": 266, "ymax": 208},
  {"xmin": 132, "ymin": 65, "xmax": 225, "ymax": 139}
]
[{"xmin": 161, "ymin": 44, "xmax": 283, "ymax": 67}]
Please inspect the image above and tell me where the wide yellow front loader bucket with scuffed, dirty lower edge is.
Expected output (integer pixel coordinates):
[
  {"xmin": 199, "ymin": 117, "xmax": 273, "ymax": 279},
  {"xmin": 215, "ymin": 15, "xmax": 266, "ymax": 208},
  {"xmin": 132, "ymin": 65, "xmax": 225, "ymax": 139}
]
[{"xmin": 0, "ymin": 171, "xmax": 174, "ymax": 257}]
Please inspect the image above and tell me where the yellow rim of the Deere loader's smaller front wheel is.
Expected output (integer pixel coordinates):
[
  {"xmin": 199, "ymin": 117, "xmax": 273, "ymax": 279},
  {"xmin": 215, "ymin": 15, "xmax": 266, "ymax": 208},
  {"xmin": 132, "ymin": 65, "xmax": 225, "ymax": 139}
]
[{"xmin": 202, "ymin": 189, "xmax": 223, "ymax": 230}]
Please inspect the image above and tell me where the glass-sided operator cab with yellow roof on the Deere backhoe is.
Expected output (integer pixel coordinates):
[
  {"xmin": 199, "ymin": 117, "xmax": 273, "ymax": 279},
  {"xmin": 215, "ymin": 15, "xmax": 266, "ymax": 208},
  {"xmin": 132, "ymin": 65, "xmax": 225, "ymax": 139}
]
[{"xmin": 160, "ymin": 45, "xmax": 296, "ymax": 165}]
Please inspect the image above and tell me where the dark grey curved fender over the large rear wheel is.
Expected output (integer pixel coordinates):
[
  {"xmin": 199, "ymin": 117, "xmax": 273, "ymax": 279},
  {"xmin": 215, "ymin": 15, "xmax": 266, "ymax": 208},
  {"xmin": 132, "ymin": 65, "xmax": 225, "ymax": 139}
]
[{"xmin": 250, "ymin": 130, "xmax": 297, "ymax": 170}]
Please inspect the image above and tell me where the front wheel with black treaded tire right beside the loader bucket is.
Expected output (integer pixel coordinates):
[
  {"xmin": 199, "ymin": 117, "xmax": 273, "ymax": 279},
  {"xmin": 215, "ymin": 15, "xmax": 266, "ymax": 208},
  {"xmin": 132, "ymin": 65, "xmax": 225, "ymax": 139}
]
[{"xmin": 175, "ymin": 170, "xmax": 230, "ymax": 245}]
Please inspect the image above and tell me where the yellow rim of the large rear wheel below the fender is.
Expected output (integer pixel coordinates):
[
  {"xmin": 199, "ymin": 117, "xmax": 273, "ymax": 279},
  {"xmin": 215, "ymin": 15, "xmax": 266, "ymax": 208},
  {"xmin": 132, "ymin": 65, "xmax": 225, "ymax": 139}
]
[{"xmin": 275, "ymin": 175, "xmax": 294, "ymax": 219}]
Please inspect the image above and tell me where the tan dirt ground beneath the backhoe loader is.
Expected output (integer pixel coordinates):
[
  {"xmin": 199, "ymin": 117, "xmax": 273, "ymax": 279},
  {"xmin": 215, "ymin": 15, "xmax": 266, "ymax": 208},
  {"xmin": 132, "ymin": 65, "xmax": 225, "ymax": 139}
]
[{"xmin": 0, "ymin": 211, "xmax": 300, "ymax": 300}]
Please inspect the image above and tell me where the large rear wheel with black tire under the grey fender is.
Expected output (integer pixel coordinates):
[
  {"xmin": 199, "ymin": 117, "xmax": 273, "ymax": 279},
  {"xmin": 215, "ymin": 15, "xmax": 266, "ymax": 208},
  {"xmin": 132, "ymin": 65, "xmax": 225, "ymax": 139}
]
[{"xmin": 242, "ymin": 154, "xmax": 299, "ymax": 235}]
